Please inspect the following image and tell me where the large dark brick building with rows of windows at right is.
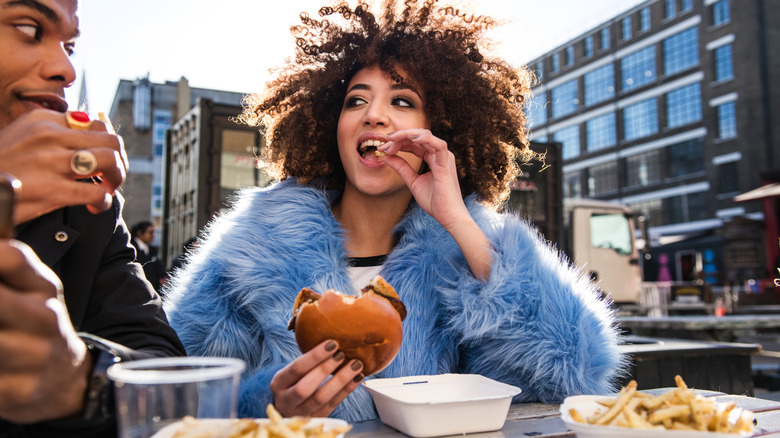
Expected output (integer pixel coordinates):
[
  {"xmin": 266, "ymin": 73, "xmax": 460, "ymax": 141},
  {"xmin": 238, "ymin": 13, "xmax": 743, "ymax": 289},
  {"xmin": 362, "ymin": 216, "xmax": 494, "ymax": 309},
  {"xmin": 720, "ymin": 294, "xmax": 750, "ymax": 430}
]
[{"xmin": 528, "ymin": 0, "xmax": 780, "ymax": 283}]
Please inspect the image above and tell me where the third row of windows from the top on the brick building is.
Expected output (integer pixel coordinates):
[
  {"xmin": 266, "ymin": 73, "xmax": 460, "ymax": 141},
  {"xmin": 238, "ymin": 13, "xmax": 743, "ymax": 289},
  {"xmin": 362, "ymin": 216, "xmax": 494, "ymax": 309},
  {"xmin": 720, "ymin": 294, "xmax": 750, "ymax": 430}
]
[{"xmin": 536, "ymin": 83, "xmax": 737, "ymax": 160}]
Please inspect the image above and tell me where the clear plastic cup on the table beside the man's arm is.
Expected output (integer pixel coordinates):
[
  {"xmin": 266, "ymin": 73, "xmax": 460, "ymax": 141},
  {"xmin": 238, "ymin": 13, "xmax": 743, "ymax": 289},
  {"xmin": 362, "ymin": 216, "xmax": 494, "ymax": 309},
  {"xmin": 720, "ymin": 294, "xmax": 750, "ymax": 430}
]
[{"xmin": 108, "ymin": 357, "xmax": 246, "ymax": 438}]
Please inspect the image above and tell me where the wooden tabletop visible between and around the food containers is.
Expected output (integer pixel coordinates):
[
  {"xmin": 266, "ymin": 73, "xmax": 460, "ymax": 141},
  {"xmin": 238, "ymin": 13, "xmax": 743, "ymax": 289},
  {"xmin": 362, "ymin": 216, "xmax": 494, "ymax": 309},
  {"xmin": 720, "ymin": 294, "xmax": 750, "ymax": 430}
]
[{"xmin": 347, "ymin": 388, "xmax": 780, "ymax": 438}]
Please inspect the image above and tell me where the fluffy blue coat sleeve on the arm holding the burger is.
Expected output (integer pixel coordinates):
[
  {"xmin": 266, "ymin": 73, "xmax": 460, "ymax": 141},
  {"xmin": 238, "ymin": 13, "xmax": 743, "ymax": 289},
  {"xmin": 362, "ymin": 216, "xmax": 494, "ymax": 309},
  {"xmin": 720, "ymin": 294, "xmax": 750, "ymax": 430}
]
[{"xmin": 165, "ymin": 181, "xmax": 316, "ymax": 417}]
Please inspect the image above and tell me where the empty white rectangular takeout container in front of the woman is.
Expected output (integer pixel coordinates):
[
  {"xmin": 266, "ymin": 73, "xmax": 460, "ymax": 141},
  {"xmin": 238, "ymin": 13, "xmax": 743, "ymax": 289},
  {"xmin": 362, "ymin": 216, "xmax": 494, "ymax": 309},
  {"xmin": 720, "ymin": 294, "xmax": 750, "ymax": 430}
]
[{"xmin": 364, "ymin": 374, "xmax": 520, "ymax": 438}]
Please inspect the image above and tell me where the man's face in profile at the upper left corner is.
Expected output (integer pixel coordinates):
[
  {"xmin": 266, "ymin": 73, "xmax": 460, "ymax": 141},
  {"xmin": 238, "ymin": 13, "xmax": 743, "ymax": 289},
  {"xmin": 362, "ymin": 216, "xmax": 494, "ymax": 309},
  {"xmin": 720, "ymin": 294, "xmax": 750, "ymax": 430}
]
[{"xmin": 0, "ymin": 0, "xmax": 78, "ymax": 129}]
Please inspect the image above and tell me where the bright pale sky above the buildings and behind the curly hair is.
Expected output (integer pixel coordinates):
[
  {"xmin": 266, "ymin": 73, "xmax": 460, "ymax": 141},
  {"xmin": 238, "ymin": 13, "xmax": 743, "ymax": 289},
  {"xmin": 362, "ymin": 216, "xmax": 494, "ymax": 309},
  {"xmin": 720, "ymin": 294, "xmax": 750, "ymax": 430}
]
[{"xmin": 66, "ymin": 0, "xmax": 644, "ymax": 113}]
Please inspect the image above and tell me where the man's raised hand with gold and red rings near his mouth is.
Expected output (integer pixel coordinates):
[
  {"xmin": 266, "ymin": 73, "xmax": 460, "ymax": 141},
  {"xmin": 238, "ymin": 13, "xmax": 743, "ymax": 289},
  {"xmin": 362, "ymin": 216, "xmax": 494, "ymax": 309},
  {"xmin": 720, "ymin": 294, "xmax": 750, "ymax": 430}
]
[{"xmin": 0, "ymin": 109, "xmax": 128, "ymax": 224}]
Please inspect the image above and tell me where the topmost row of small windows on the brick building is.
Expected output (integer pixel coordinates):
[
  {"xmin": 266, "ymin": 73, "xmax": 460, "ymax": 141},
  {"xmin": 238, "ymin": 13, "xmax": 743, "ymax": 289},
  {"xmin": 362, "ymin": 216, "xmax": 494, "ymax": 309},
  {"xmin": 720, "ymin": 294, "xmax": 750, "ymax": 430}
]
[{"xmin": 536, "ymin": 0, "xmax": 731, "ymax": 77}]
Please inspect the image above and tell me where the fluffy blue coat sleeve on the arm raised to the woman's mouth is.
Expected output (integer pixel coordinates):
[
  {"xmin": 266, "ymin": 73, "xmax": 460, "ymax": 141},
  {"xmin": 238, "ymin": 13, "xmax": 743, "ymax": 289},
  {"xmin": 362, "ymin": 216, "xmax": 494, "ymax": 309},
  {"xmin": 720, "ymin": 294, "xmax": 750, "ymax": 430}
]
[{"xmin": 442, "ymin": 204, "xmax": 625, "ymax": 403}]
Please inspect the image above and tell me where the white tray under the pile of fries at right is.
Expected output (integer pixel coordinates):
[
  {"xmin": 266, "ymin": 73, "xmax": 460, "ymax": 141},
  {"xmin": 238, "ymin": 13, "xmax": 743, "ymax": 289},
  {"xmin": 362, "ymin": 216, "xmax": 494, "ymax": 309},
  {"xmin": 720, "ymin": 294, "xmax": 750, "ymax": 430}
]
[{"xmin": 561, "ymin": 395, "xmax": 751, "ymax": 438}]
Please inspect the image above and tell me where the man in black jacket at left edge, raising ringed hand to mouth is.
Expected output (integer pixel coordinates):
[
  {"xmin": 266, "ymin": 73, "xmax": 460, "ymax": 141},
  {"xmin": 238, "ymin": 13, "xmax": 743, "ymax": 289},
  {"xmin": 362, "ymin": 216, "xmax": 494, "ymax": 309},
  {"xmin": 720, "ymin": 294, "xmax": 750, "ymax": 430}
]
[{"xmin": 0, "ymin": 0, "xmax": 184, "ymax": 437}]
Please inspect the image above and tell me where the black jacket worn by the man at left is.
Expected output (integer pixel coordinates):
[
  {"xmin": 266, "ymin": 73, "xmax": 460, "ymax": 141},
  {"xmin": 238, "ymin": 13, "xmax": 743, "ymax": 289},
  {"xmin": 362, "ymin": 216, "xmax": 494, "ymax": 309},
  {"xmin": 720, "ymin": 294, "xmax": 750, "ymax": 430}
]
[{"xmin": 0, "ymin": 196, "xmax": 185, "ymax": 437}]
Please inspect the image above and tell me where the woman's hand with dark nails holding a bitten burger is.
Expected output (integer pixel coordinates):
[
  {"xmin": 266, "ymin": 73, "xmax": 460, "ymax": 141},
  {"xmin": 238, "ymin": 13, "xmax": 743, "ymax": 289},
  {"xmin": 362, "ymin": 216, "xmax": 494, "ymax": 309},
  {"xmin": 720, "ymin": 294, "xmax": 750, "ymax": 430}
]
[{"xmin": 270, "ymin": 276, "xmax": 406, "ymax": 417}]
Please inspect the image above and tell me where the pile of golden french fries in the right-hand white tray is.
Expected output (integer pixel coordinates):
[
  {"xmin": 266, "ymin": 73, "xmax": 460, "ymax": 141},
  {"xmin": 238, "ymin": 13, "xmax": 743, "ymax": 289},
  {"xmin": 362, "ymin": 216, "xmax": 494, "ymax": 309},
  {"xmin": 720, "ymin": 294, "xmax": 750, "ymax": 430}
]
[{"xmin": 569, "ymin": 376, "xmax": 753, "ymax": 434}]
